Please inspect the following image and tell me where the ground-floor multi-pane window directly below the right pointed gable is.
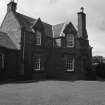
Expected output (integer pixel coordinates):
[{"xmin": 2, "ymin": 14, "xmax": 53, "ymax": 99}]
[{"xmin": 66, "ymin": 57, "xmax": 74, "ymax": 71}]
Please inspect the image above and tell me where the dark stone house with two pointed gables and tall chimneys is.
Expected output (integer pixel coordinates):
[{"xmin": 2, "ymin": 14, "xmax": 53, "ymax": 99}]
[{"xmin": 0, "ymin": 0, "xmax": 92, "ymax": 79}]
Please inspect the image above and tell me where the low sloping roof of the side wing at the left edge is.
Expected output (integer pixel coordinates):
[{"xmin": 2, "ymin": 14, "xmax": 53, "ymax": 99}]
[{"xmin": 0, "ymin": 32, "xmax": 18, "ymax": 50}]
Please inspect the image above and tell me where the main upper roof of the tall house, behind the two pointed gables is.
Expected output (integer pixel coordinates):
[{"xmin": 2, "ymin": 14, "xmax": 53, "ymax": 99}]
[{"xmin": 15, "ymin": 12, "xmax": 76, "ymax": 38}]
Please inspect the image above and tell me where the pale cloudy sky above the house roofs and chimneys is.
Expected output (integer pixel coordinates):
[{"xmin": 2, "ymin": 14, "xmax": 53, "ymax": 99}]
[{"xmin": 0, "ymin": 0, "xmax": 105, "ymax": 57}]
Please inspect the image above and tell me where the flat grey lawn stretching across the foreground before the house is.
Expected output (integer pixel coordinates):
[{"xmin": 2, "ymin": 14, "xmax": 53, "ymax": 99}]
[{"xmin": 0, "ymin": 81, "xmax": 105, "ymax": 105}]
